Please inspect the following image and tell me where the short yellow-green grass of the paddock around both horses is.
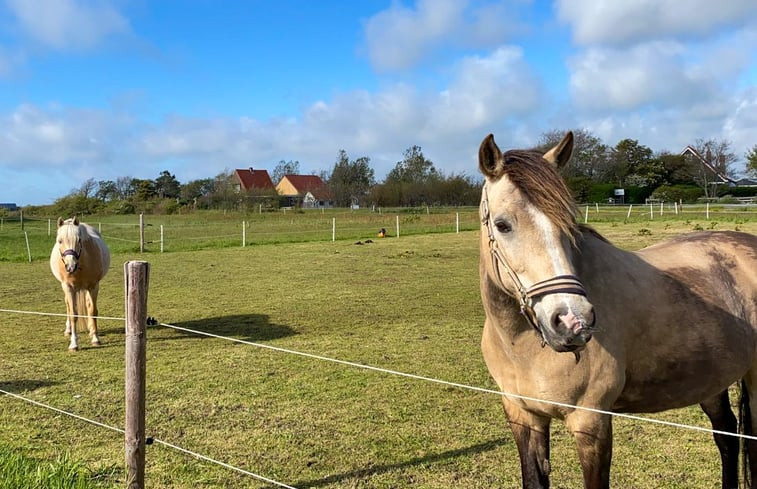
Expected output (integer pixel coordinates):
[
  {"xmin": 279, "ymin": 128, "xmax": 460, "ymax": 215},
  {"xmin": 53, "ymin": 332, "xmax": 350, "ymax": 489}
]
[{"xmin": 0, "ymin": 209, "xmax": 757, "ymax": 489}]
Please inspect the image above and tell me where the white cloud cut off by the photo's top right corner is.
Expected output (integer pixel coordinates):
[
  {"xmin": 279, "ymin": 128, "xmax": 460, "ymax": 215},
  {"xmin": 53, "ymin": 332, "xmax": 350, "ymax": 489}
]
[{"xmin": 557, "ymin": 0, "xmax": 757, "ymax": 44}]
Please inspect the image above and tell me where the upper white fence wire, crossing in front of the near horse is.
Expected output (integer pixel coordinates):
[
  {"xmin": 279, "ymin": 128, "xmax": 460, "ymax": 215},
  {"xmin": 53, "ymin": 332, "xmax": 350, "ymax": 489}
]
[{"xmin": 0, "ymin": 309, "xmax": 757, "ymax": 441}]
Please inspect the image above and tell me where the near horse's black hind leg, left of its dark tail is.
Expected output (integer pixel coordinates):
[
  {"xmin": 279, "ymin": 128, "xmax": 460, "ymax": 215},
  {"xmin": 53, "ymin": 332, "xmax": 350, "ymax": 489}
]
[{"xmin": 700, "ymin": 389, "xmax": 739, "ymax": 489}]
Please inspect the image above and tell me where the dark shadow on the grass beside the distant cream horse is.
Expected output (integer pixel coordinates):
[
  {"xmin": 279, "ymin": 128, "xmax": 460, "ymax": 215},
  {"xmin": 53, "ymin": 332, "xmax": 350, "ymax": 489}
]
[{"xmin": 155, "ymin": 314, "xmax": 297, "ymax": 342}]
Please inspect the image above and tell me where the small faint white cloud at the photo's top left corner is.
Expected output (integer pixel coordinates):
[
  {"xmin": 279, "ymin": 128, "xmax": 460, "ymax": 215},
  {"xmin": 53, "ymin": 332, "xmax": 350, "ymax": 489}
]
[{"xmin": 6, "ymin": 0, "xmax": 130, "ymax": 50}]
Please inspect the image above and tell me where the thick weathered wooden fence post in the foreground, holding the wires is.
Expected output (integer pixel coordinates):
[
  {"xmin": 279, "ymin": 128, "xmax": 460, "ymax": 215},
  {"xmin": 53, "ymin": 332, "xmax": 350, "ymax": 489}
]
[{"xmin": 124, "ymin": 261, "xmax": 150, "ymax": 489}]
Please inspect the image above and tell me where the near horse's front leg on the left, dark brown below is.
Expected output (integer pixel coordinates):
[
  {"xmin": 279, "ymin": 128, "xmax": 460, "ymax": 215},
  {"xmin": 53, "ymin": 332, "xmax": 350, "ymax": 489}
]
[{"xmin": 502, "ymin": 397, "xmax": 551, "ymax": 489}]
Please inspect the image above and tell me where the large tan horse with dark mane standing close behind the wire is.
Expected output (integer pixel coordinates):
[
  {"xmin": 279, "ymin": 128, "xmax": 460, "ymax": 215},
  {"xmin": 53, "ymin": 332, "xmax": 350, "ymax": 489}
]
[{"xmin": 479, "ymin": 133, "xmax": 757, "ymax": 489}]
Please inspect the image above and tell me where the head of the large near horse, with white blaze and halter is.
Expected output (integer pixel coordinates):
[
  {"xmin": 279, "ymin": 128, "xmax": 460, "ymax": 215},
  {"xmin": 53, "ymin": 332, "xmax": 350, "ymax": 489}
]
[{"xmin": 479, "ymin": 132, "xmax": 595, "ymax": 352}]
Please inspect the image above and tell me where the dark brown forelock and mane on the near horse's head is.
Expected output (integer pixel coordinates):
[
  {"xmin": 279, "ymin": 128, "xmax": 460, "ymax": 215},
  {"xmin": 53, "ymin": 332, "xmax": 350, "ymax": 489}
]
[{"xmin": 502, "ymin": 149, "xmax": 580, "ymax": 244}]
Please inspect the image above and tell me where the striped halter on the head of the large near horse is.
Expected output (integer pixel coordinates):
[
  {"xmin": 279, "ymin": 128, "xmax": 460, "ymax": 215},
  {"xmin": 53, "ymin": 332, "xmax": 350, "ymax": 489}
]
[{"xmin": 481, "ymin": 185, "xmax": 586, "ymax": 342}]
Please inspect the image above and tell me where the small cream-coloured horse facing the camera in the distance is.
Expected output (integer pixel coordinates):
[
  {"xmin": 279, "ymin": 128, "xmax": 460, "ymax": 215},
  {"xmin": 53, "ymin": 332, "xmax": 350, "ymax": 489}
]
[{"xmin": 50, "ymin": 217, "xmax": 110, "ymax": 350}]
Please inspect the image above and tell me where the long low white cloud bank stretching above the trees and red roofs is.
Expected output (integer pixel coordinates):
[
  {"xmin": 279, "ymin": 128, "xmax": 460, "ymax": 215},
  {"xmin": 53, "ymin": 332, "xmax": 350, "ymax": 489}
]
[{"xmin": 0, "ymin": 41, "xmax": 542, "ymax": 202}]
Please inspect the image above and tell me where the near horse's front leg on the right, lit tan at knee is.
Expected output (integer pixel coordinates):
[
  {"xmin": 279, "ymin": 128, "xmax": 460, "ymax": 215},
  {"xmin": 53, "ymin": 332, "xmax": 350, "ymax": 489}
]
[{"xmin": 565, "ymin": 410, "xmax": 612, "ymax": 489}]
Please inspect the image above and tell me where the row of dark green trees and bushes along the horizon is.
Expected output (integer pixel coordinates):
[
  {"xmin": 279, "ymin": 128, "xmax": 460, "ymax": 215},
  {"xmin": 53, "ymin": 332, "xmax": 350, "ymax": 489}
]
[{"xmin": 23, "ymin": 129, "xmax": 757, "ymax": 215}]
